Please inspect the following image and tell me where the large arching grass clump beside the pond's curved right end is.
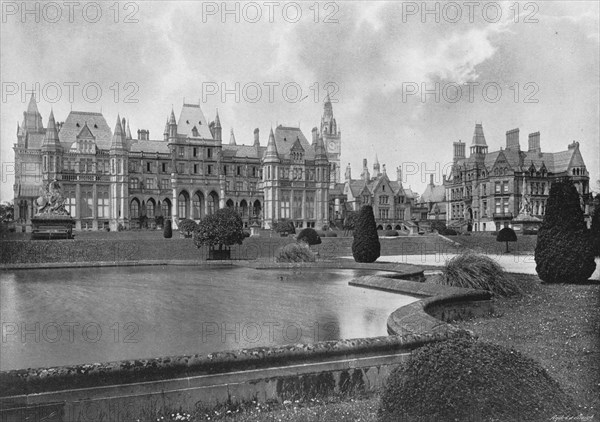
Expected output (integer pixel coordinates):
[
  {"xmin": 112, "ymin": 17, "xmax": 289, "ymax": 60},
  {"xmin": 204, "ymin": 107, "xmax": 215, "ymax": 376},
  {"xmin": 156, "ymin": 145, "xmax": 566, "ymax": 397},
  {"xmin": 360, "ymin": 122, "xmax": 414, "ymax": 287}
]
[{"xmin": 435, "ymin": 252, "xmax": 522, "ymax": 296}]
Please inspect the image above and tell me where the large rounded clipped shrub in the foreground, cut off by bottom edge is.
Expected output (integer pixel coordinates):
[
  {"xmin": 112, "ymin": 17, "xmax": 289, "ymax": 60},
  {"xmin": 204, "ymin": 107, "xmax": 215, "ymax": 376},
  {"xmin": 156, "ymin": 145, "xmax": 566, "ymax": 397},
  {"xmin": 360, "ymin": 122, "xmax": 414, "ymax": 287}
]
[{"xmin": 379, "ymin": 337, "xmax": 577, "ymax": 422}]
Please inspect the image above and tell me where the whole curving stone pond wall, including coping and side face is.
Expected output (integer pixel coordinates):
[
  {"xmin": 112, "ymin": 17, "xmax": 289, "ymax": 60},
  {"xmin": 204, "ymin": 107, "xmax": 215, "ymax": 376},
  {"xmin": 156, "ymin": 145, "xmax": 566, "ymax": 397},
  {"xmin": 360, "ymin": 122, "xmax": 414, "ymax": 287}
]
[{"xmin": 0, "ymin": 260, "xmax": 492, "ymax": 421}]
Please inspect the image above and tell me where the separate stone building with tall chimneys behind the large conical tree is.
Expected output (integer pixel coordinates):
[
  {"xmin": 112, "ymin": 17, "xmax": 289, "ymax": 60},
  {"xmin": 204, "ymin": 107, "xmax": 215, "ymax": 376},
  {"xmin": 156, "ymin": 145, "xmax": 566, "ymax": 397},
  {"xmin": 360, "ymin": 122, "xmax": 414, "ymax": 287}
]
[{"xmin": 444, "ymin": 124, "xmax": 592, "ymax": 231}]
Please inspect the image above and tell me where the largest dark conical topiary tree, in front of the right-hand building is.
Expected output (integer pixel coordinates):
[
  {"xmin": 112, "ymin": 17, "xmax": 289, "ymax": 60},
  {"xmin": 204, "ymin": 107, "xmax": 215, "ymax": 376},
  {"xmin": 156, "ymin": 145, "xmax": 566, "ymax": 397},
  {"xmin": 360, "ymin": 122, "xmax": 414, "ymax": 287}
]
[{"xmin": 535, "ymin": 180, "xmax": 596, "ymax": 283}]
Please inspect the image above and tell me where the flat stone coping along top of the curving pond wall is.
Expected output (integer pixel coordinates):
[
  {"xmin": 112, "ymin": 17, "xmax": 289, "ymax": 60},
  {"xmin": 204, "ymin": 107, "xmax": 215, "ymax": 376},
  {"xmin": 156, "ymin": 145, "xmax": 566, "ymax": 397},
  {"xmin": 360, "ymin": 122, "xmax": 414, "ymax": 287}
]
[{"xmin": 0, "ymin": 262, "xmax": 491, "ymax": 400}]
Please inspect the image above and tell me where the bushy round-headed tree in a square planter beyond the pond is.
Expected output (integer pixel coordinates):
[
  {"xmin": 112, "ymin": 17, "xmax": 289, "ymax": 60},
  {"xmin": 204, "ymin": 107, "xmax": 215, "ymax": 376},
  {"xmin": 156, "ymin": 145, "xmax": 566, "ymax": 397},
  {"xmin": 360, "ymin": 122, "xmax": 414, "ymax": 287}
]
[{"xmin": 194, "ymin": 208, "xmax": 245, "ymax": 260}]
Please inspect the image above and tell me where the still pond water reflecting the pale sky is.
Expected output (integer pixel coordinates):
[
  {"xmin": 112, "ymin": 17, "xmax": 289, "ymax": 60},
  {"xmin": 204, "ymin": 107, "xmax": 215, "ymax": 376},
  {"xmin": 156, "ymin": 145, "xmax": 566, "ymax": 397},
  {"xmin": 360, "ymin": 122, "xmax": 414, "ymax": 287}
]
[{"xmin": 0, "ymin": 266, "xmax": 417, "ymax": 370}]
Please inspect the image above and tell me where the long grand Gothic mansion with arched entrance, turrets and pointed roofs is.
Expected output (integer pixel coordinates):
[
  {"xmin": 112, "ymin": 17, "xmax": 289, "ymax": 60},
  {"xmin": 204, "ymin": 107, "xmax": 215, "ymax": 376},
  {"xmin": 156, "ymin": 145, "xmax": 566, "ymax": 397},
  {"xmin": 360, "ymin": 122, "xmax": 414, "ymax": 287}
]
[{"xmin": 14, "ymin": 96, "xmax": 350, "ymax": 230}]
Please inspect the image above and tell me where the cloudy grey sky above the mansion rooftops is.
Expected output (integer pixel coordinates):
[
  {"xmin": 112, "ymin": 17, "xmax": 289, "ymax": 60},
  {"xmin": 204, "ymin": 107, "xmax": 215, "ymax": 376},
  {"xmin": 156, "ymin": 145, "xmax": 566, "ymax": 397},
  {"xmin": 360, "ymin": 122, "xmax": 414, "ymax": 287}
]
[{"xmin": 0, "ymin": 1, "xmax": 600, "ymax": 201}]
